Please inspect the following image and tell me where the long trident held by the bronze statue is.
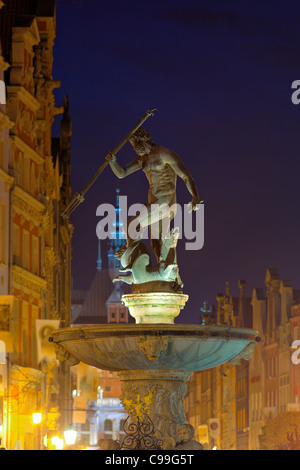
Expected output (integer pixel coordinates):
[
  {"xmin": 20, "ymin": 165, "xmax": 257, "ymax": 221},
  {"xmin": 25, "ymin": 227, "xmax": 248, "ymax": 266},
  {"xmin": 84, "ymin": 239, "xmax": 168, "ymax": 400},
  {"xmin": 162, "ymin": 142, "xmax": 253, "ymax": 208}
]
[{"xmin": 61, "ymin": 108, "xmax": 157, "ymax": 219}]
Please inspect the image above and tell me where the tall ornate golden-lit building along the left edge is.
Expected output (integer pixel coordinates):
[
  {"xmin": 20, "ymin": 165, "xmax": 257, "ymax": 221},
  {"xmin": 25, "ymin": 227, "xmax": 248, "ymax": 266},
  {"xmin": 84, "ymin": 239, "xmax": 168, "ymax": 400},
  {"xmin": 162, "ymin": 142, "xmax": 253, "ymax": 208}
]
[{"xmin": 0, "ymin": 0, "xmax": 73, "ymax": 449}]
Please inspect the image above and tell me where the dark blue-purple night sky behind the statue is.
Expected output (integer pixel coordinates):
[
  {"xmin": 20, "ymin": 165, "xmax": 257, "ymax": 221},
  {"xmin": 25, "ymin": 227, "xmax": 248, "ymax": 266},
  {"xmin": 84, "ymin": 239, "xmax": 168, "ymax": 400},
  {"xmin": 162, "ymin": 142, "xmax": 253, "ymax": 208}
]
[{"xmin": 53, "ymin": 0, "xmax": 300, "ymax": 323}]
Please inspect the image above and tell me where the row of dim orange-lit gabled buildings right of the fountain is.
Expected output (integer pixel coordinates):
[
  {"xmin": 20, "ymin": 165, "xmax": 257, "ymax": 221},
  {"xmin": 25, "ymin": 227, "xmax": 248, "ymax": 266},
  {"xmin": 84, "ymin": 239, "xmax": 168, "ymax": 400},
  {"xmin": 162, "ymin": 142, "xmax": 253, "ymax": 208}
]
[{"xmin": 186, "ymin": 268, "xmax": 300, "ymax": 450}]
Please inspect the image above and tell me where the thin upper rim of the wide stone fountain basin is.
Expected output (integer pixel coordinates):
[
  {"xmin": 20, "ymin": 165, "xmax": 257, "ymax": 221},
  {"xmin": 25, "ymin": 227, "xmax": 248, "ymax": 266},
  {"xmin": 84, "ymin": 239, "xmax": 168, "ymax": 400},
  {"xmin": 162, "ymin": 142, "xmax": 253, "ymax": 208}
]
[{"xmin": 49, "ymin": 323, "xmax": 260, "ymax": 343}]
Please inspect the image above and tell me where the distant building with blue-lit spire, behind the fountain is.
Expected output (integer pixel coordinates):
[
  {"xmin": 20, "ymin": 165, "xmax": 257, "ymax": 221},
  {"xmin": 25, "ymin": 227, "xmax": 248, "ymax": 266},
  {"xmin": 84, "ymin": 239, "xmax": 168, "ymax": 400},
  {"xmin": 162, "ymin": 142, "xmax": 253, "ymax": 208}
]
[{"xmin": 72, "ymin": 188, "xmax": 134, "ymax": 448}]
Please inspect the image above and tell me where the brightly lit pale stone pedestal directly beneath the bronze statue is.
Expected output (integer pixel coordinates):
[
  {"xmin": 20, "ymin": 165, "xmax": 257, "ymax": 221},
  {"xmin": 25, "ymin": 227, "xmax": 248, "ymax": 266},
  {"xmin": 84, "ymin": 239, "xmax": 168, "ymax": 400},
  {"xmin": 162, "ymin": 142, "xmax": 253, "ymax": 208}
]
[{"xmin": 122, "ymin": 292, "xmax": 189, "ymax": 324}]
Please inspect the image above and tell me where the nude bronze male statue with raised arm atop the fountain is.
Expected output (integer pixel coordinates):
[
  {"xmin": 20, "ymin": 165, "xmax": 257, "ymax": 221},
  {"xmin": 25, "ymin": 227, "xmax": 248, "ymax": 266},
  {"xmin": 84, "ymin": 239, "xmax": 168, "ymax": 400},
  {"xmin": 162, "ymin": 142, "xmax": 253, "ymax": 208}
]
[{"xmin": 108, "ymin": 128, "xmax": 202, "ymax": 287}]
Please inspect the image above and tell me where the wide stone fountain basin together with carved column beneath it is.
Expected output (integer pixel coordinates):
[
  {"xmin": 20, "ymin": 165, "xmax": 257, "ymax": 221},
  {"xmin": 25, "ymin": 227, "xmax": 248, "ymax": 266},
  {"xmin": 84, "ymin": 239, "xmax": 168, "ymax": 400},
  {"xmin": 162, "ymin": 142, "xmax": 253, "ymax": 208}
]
[{"xmin": 51, "ymin": 307, "xmax": 257, "ymax": 450}]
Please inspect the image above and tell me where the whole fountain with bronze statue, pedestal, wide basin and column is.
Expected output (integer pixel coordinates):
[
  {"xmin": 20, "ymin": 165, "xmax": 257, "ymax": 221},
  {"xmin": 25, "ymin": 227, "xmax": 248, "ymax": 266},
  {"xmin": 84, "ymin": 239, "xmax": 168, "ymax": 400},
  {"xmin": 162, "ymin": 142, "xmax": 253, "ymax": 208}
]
[{"xmin": 50, "ymin": 118, "xmax": 258, "ymax": 450}]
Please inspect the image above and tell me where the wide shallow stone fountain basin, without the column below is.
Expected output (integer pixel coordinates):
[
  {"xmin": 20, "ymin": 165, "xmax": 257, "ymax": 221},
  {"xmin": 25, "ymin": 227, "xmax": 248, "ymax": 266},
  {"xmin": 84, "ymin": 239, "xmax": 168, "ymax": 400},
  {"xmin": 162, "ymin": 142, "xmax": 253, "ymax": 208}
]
[{"xmin": 51, "ymin": 324, "xmax": 258, "ymax": 372}]
